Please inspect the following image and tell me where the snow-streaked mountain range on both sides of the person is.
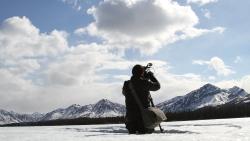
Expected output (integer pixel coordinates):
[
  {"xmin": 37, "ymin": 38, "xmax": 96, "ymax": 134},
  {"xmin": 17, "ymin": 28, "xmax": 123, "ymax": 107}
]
[{"xmin": 0, "ymin": 84, "xmax": 250, "ymax": 124}]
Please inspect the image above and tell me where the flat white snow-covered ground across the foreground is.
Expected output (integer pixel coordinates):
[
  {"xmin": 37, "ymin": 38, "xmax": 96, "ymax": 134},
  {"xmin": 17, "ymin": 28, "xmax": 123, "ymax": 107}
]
[{"xmin": 0, "ymin": 118, "xmax": 250, "ymax": 141}]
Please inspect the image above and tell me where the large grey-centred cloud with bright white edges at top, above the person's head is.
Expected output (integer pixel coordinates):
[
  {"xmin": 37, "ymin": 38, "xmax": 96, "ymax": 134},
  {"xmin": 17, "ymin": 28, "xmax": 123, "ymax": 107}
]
[{"xmin": 75, "ymin": 0, "xmax": 225, "ymax": 54}]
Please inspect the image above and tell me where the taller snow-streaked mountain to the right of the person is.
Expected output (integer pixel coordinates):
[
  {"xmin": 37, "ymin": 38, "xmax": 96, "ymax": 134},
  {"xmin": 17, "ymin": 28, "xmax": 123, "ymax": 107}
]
[{"xmin": 157, "ymin": 84, "xmax": 248, "ymax": 112}]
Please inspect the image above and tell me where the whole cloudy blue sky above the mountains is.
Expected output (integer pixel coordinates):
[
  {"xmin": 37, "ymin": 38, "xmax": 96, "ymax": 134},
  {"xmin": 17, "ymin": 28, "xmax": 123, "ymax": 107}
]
[{"xmin": 0, "ymin": 0, "xmax": 250, "ymax": 113}]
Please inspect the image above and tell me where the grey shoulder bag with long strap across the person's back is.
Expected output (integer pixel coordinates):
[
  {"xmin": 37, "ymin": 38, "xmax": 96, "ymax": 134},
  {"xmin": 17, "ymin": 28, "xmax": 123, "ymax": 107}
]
[{"xmin": 129, "ymin": 82, "xmax": 167, "ymax": 129}]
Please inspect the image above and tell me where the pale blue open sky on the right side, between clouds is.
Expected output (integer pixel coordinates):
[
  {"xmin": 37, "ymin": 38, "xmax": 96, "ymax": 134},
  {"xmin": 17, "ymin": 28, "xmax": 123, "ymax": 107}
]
[{"xmin": 156, "ymin": 0, "xmax": 250, "ymax": 79}]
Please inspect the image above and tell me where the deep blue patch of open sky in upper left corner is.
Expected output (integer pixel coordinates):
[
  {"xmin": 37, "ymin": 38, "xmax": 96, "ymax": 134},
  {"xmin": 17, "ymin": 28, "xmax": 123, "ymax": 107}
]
[{"xmin": 1, "ymin": 0, "xmax": 91, "ymax": 32}]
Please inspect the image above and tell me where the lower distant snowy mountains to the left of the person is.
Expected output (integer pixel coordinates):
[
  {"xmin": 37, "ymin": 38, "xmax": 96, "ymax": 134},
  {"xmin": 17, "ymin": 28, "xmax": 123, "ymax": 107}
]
[{"xmin": 0, "ymin": 99, "xmax": 126, "ymax": 124}]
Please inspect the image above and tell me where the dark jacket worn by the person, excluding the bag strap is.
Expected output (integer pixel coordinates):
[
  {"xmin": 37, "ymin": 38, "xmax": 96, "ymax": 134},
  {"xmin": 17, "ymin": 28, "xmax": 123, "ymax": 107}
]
[{"xmin": 122, "ymin": 74, "xmax": 160, "ymax": 121}]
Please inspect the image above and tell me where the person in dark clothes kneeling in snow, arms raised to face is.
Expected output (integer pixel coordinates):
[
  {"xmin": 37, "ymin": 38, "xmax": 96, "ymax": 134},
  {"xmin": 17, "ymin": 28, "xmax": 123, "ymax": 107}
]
[{"xmin": 122, "ymin": 64, "xmax": 160, "ymax": 134}]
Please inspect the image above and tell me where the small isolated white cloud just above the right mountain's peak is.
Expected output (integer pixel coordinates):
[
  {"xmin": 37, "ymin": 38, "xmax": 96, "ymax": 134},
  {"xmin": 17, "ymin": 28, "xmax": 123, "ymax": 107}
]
[{"xmin": 193, "ymin": 57, "xmax": 235, "ymax": 76}]
